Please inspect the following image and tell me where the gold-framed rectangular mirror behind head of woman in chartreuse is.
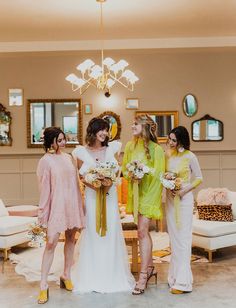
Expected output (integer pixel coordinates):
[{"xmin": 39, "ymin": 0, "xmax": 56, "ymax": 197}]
[{"xmin": 136, "ymin": 111, "xmax": 179, "ymax": 143}]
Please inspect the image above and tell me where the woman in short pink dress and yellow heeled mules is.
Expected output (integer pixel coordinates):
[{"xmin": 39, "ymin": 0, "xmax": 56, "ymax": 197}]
[{"xmin": 37, "ymin": 127, "xmax": 85, "ymax": 304}]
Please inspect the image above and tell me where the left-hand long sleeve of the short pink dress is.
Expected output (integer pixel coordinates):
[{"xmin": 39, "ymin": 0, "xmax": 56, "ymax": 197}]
[{"xmin": 37, "ymin": 158, "xmax": 51, "ymax": 227}]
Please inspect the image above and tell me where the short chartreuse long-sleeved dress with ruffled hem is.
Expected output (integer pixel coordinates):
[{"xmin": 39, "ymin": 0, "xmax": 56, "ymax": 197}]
[{"xmin": 122, "ymin": 138, "xmax": 165, "ymax": 219}]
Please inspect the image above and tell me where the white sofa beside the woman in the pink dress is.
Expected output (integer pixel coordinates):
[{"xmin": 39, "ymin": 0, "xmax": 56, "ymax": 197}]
[{"xmin": 0, "ymin": 199, "xmax": 37, "ymax": 261}]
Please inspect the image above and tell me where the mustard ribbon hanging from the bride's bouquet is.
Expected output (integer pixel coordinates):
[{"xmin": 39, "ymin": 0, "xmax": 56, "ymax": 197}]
[{"xmin": 96, "ymin": 186, "xmax": 107, "ymax": 236}]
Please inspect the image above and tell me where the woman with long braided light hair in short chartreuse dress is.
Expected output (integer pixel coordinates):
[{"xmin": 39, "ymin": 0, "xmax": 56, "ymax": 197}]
[{"xmin": 122, "ymin": 114, "xmax": 165, "ymax": 295}]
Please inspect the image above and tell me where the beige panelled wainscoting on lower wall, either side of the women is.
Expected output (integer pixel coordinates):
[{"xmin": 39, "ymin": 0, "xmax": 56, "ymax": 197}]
[{"xmin": 0, "ymin": 151, "xmax": 236, "ymax": 205}]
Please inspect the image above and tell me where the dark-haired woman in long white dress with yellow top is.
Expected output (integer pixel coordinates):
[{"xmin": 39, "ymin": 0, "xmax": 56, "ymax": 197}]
[{"xmin": 166, "ymin": 126, "xmax": 202, "ymax": 294}]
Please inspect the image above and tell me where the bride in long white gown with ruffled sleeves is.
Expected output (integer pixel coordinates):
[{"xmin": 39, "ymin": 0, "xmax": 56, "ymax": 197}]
[{"xmin": 72, "ymin": 118, "xmax": 134, "ymax": 293}]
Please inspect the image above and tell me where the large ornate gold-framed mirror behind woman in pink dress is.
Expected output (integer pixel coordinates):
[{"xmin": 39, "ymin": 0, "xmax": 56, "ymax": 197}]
[{"xmin": 27, "ymin": 98, "xmax": 83, "ymax": 148}]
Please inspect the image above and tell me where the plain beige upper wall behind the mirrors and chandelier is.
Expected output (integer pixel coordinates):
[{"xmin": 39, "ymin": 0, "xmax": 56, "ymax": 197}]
[{"xmin": 0, "ymin": 49, "xmax": 236, "ymax": 154}]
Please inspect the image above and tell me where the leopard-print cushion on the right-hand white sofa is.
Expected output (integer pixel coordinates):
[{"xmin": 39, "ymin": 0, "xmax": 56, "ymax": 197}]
[{"xmin": 197, "ymin": 204, "xmax": 233, "ymax": 221}]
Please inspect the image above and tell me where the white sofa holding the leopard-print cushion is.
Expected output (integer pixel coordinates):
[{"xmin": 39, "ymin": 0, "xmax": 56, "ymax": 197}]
[{"xmin": 192, "ymin": 191, "xmax": 236, "ymax": 262}]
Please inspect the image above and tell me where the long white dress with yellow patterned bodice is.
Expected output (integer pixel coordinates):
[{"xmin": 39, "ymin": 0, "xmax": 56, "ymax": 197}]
[{"xmin": 166, "ymin": 150, "xmax": 202, "ymax": 292}]
